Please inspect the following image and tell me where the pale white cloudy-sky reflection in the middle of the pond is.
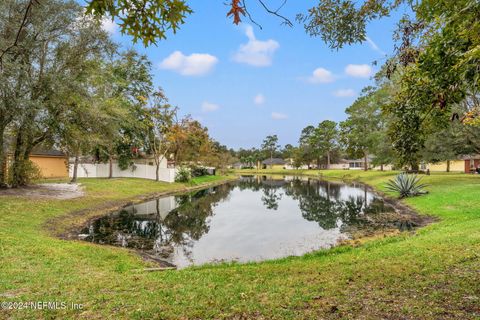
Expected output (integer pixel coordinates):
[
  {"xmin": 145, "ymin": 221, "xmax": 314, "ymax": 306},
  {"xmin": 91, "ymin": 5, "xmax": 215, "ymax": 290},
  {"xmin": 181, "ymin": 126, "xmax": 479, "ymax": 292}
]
[{"xmin": 171, "ymin": 190, "xmax": 342, "ymax": 265}]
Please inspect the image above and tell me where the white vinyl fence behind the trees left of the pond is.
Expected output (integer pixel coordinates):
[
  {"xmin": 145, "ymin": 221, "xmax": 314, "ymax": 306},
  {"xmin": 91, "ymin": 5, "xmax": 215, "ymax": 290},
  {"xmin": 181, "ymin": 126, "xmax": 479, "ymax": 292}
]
[{"xmin": 68, "ymin": 163, "xmax": 176, "ymax": 182}]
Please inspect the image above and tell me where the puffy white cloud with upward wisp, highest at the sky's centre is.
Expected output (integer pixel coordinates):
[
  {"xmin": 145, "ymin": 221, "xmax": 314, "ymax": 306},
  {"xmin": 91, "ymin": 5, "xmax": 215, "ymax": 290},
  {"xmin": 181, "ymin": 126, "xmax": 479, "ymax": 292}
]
[{"xmin": 233, "ymin": 25, "xmax": 280, "ymax": 67}]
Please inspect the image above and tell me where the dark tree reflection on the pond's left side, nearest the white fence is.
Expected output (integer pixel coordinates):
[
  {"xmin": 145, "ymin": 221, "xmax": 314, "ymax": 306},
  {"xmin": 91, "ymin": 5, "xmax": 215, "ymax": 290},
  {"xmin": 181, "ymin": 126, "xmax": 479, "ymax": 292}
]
[{"xmin": 83, "ymin": 184, "xmax": 233, "ymax": 258}]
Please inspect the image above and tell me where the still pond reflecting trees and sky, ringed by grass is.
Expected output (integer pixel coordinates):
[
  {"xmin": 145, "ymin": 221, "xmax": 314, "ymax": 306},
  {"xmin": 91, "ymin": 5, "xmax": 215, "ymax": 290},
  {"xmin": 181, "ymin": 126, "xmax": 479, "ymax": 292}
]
[{"xmin": 79, "ymin": 176, "xmax": 411, "ymax": 268}]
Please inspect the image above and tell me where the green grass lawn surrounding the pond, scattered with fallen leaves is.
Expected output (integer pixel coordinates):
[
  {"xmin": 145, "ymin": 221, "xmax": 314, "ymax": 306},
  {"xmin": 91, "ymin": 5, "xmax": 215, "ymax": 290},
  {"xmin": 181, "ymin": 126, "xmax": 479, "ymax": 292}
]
[{"xmin": 0, "ymin": 170, "xmax": 480, "ymax": 319}]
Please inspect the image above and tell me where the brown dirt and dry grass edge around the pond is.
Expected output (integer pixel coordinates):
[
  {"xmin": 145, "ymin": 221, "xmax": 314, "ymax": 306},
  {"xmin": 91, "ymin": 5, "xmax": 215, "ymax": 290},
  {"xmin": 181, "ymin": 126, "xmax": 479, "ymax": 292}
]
[{"xmin": 47, "ymin": 175, "xmax": 439, "ymax": 268}]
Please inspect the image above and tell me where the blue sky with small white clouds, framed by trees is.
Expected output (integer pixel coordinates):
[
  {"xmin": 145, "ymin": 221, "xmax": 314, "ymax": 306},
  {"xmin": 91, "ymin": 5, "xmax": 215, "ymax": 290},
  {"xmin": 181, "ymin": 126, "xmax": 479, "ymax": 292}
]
[{"xmin": 105, "ymin": 0, "xmax": 403, "ymax": 148}]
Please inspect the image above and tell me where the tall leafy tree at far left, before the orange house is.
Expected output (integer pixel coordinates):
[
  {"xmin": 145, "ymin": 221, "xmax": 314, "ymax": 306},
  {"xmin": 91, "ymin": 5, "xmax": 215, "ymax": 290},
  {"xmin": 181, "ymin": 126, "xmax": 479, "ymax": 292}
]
[{"xmin": 0, "ymin": 0, "xmax": 110, "ymax": 186}]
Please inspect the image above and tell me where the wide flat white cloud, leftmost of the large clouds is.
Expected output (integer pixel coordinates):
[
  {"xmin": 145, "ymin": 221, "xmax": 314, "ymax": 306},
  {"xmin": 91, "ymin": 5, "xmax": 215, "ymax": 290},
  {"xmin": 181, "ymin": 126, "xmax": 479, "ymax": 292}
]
[{"xmin": 160, "ymin": 51, "xmax": 218, "ymax": 76}]
